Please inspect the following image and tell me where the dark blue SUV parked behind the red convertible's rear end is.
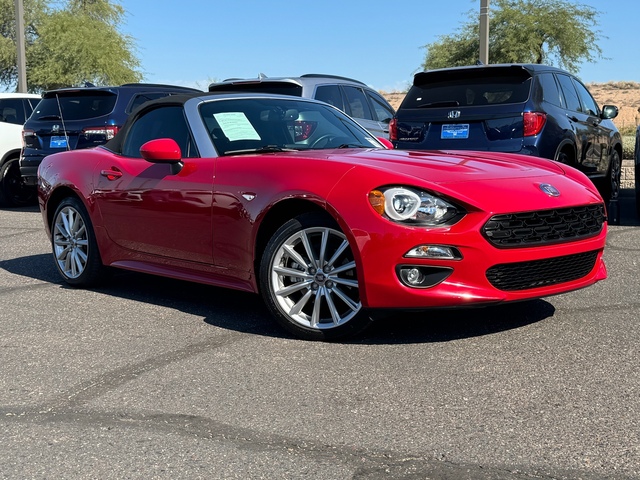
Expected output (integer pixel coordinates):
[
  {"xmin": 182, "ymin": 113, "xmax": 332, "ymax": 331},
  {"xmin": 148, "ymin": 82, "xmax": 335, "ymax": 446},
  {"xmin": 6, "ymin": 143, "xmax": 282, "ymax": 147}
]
[{"xmin": 20, "ymin": 83, "xmax": 201, "ymax": 187}]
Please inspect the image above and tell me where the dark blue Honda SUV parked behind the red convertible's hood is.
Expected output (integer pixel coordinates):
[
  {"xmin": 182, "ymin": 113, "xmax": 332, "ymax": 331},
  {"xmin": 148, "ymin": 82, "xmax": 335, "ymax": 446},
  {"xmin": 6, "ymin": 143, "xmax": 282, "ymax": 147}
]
[{"xmin": 390, "ymin": 64, "xmax": 622, "ymax": 201}]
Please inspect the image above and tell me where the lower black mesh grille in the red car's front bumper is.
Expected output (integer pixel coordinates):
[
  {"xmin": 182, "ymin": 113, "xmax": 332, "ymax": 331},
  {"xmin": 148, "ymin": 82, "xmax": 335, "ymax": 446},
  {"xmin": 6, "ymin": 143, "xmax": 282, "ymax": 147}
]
[{"xmin": 487, "ymin": 250, "xmax": 598, "ymax": 291}]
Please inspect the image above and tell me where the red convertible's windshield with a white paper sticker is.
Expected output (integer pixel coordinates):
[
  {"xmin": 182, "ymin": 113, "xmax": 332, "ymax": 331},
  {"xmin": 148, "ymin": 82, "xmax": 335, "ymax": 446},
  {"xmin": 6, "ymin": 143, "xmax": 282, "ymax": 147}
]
[{"xmin": 200, "ymin": 98, "xmax": 382, "ymax": 155}]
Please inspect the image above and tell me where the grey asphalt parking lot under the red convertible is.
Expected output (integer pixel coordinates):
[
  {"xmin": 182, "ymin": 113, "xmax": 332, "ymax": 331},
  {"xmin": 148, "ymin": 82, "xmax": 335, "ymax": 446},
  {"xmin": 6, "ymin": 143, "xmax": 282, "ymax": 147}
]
[{"xmin": 0, "ymin": 190, "xmax": 640, "ymax": 480}]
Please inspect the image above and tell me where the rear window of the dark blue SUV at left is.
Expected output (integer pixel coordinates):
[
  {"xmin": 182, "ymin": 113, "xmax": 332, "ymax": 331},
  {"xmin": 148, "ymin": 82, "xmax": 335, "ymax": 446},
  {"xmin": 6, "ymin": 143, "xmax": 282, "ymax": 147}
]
[{"xmin": 33, "ymin": 92, "xmax": 118, "ymax": 121}]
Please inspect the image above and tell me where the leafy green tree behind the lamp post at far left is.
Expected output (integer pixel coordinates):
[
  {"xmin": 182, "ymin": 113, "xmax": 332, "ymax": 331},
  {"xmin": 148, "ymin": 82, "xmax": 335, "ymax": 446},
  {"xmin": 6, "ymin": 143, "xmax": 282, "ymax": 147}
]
[{"xmin": 0, "ymin": 0, "xmax": 142, "ymax": 92}]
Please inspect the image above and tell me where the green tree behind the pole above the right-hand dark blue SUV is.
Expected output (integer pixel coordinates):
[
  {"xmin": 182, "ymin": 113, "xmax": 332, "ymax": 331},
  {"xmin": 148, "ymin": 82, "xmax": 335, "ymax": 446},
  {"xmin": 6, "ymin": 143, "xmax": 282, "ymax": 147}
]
[{"xmin": 423, "ymin": 0, "xmax": 602, "ymax": 73}]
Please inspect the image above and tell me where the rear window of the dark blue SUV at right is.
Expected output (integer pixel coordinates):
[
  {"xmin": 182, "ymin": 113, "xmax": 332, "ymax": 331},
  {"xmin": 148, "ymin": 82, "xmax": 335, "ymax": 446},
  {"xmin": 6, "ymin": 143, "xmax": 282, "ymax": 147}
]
[{"xmin": 402, "ymin": 72, "xmax": 531, "ymax": 108}]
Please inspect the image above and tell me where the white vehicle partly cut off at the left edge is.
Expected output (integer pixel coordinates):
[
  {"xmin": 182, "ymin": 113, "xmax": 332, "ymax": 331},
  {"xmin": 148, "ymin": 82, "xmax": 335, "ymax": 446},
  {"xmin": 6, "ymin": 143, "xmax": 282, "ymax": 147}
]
[{"xmin": 0, "ymin": 93, "xmax": 40, "ymax": 207}]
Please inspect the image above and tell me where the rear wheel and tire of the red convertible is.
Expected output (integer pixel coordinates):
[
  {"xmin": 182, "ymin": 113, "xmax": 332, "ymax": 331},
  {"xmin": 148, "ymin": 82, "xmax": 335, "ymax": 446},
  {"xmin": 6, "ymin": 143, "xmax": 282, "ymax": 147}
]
[{"xmin": 51, "ymin": 197, "xmax": 105, "ymax": 287}]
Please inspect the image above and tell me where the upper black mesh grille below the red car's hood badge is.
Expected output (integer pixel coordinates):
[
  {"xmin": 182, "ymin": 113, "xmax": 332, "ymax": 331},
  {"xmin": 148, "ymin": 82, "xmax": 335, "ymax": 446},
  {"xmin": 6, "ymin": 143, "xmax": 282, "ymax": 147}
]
[{"xmin": 482, "ymin": 204, "xmax": 606, "ymax": 248}]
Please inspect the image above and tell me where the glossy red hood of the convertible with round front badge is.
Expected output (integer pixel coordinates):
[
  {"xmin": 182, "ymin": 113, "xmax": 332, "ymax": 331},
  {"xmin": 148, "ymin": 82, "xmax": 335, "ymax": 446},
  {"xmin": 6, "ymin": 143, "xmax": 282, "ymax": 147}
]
[{"xmin": 325, "ymin": 150, "xmax": 602, "ymax": 213}]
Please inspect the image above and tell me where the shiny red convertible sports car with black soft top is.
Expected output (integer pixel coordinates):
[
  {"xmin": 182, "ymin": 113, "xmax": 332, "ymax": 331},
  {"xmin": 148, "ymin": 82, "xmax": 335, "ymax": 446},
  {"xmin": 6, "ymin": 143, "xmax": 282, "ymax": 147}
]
[{"xmin": 39, "ymin": 93, "xmax": 607, "ymax": 340}]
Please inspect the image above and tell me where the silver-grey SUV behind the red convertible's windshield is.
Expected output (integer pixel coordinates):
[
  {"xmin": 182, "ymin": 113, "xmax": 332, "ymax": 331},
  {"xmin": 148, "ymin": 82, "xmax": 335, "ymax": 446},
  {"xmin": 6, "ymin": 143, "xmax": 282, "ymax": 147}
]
[{"xmin": 209, "ymin": 74, "xmax": 395, "ymax": 138}]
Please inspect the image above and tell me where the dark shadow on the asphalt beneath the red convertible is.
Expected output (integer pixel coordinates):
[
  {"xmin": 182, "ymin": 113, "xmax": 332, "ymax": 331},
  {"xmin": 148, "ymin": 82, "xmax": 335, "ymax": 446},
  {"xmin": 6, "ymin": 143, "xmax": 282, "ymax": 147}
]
[{"xmin": 0, "ymin": 254, "xmax": 554, "ymax": 344}]
